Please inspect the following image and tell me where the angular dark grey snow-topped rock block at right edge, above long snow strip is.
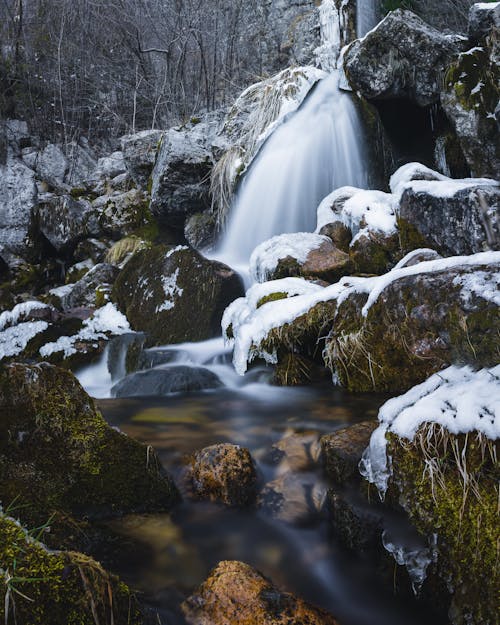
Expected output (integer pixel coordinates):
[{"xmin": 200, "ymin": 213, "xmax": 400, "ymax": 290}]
[{"xmin": 399, "ymin": 181, "xmax": 500, "ymax": 256}]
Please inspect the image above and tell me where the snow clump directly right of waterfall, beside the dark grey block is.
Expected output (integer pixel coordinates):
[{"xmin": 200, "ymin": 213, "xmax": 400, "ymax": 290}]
[{"xmin": 316, "ymin": 187, "xmax": 396, "ymax": 245}]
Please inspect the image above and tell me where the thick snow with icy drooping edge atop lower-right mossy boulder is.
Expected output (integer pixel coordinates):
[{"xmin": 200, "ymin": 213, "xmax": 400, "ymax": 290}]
[{"xmin": 360, "ymin": 365, "xmax": 500, "ymax": 495}]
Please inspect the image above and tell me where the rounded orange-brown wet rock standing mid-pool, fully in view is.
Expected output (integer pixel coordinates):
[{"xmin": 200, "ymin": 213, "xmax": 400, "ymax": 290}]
[{"xmin": 189, "ymin": 443, "xmax": 257, "ymax": 506}]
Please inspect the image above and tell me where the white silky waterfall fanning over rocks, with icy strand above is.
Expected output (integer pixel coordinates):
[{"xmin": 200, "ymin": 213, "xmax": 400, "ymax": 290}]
[{"xmin": 215, "ymin": 0, "xmax": 368, "ymax": 268}]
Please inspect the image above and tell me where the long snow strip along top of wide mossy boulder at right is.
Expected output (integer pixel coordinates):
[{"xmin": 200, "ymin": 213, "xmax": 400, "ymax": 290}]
[{"xmin": 226, "ymin": 252, "xmax": 500, "ymax": 375}]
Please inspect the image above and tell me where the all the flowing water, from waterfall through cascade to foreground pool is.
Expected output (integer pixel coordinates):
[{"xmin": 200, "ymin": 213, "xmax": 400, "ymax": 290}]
[{"xmin": 77, "ymin": 0, "xmax": 438, "ymax": 625}]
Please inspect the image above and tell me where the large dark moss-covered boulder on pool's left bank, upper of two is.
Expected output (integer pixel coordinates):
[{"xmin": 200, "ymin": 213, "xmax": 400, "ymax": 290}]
[{"xmin": 0, "ymin": 364, "xmax": 177, "ymax": 522}]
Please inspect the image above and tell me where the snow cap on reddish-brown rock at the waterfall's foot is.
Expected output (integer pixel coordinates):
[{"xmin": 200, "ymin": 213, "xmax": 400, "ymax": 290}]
[{"xmin": 250, "ymin": 232, "xmax": 331, "ymax": 282}]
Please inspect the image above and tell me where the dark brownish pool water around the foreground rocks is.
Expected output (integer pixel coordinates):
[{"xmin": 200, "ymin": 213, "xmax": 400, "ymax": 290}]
[{"xmin": 98, "ymin": 387, "xmax": 442, "ymax": 625}]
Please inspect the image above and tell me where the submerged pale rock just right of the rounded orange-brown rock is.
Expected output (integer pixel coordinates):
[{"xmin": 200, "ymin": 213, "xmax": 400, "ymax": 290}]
[{"xmin": 257, "ymin": 473, "xmax": 325, "ymax": 526}]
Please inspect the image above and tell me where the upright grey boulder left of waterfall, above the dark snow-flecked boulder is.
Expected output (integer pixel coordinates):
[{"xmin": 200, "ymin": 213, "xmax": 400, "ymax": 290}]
[{"xmin": 147, "ymin": 126, "xmax": 213, "ymax": 229}]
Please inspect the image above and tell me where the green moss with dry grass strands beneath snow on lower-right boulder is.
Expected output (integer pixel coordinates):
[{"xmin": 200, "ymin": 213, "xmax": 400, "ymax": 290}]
[{"xmin": 388, "ymin": 424, "xmax": 500, "ymax": 625}]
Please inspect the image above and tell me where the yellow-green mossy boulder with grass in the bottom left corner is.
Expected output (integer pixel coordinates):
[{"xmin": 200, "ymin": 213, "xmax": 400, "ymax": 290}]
[{"xmin": 0, "ymin": 512, "xmax": 142, "ymax": 625}]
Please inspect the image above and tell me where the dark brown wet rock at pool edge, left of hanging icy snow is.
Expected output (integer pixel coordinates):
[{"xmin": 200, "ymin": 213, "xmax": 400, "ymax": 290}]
[{"xmin": 321, "ymin": 419, "xmax": 378, "ymax": 485}]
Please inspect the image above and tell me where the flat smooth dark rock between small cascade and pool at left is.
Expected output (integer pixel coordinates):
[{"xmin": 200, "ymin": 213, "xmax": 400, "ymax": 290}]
[{"xmin": 111, "ymin": 365, "xmax": 222, "ymax": 397}]
